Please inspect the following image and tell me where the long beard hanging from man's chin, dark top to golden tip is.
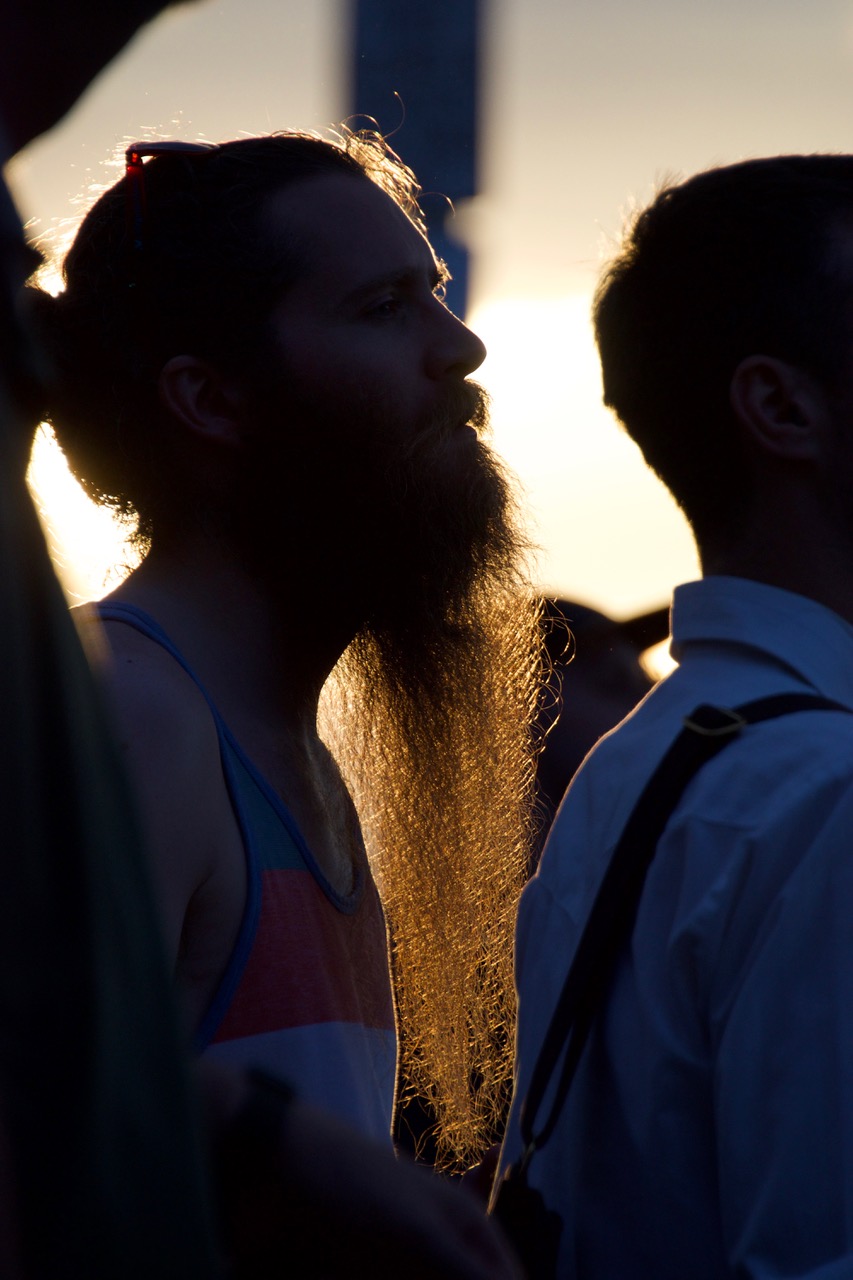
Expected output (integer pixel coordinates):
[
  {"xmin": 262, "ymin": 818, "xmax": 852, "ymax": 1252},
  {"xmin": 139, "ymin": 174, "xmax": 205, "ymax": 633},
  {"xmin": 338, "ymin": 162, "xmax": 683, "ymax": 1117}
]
[{"xmin": 318, "ymin": 393, "xmax": 540, "ymax": 1165}]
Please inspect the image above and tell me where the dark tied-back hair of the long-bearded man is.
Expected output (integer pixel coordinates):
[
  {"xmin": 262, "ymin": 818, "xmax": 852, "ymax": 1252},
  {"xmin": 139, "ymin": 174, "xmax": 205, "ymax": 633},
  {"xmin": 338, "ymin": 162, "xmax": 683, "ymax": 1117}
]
[{"xmin": 29, "ymin": 129, "xmax": 424, "ymax": 541}]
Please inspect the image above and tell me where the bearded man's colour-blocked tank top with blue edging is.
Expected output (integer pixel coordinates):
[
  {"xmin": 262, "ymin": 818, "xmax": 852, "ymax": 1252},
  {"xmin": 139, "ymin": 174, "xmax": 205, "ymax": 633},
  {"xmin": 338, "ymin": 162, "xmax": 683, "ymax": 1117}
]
[{"xmin": 96, "ymin": 602, "xmax": 397, "ymax": 1140}]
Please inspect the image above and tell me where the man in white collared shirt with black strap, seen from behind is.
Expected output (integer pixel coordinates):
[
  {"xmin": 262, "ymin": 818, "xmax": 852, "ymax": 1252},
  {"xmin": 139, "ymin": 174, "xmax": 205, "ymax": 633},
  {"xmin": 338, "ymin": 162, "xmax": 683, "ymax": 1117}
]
[{"xmin": 502, "ymin": 156, "xmax": 853, "ymax": 1280}]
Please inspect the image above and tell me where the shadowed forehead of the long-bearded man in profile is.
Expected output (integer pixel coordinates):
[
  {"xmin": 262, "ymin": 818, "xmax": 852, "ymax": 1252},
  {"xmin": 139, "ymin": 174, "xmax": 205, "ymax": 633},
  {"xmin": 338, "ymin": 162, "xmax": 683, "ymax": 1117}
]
[{"xmin": 265, "ymin": 174, "xmax": 438, "ymax": 307}]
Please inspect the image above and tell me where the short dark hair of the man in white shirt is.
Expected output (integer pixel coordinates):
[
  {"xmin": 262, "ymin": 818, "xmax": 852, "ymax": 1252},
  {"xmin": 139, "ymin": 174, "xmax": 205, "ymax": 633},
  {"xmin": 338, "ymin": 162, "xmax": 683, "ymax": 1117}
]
[{"xmin": 593, "ymin": 155, "xmax": 853, "ymax": 544}]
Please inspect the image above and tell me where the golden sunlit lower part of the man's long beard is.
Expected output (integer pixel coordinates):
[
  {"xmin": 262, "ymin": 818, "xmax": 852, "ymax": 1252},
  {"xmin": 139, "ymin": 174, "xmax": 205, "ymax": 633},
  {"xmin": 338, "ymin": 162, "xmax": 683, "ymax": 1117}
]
[{"xmin": 324, "ymin": 532, "xmax": 543, "ymax": 1167}]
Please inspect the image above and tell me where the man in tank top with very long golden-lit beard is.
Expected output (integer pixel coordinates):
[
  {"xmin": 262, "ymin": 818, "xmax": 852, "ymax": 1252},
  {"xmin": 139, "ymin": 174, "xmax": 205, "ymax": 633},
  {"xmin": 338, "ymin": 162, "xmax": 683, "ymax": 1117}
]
[{"xmin": 32, "ymin": 134, "xmax": 538, "ymax": 1172}]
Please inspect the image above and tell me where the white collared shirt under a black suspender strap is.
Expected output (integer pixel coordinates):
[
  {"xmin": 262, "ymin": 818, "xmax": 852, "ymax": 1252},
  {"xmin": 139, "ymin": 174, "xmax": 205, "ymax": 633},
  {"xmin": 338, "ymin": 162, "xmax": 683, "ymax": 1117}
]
[{"xmin": 502, "ymin": 577, "xmax": 853, "ymax": 1280}]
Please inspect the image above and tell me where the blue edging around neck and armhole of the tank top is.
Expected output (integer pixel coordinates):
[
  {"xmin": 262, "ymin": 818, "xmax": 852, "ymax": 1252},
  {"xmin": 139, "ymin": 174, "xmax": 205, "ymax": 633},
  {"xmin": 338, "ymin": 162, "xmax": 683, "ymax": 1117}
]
[{"xmin": 93, "ymin": 600, "xmax": 365, "ymax": 1053}]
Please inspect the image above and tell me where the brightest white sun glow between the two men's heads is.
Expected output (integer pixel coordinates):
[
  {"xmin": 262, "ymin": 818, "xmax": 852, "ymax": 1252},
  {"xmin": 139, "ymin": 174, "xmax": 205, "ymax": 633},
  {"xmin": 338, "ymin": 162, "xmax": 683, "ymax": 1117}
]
[{"xmin": 470, "ymin": 294, "xmax": 698, "ymax": 617}]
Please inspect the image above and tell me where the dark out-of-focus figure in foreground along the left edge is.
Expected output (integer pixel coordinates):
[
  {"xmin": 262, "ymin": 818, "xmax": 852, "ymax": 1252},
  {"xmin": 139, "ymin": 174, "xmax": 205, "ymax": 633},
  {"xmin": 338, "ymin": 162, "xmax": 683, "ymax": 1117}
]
[{"xmin": 0, "ymin": 3, "xmax": 218, "ymax": 1280}]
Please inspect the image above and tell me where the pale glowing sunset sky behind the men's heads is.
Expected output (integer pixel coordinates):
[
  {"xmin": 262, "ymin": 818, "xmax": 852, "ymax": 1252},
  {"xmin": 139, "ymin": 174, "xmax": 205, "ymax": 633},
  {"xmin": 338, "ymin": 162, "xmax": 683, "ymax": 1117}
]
[{"xmin": 10, "ymin": 0, "xmax": 853, "ymax": 616}]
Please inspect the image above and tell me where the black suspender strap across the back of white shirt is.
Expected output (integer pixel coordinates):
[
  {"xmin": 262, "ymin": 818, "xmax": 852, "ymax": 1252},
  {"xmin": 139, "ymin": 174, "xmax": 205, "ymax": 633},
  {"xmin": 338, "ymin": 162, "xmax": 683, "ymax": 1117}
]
[{"xmin": 519, "ymin": 692, "xmax": 850, "ymax": 1172}]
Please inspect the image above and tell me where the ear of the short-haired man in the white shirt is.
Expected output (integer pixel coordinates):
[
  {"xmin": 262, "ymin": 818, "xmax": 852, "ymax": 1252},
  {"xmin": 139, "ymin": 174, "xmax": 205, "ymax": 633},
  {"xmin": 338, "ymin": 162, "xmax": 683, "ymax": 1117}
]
[{"xmin": 729, "ymin": 356, "xmax": 825, "ymax": 461}]
